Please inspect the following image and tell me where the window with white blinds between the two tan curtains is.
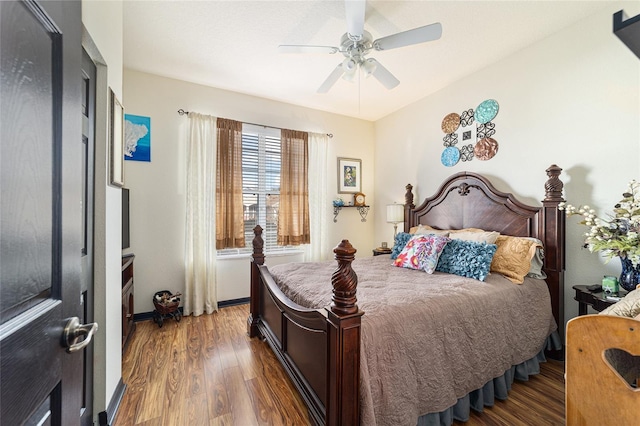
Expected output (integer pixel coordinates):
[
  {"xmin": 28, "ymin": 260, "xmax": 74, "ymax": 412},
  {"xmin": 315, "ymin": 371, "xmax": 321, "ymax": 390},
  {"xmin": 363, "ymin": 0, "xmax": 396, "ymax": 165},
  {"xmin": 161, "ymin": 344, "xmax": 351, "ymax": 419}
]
[{"xmin": 218, "ymin": 123, "xmax": 300, "ymax": 256}]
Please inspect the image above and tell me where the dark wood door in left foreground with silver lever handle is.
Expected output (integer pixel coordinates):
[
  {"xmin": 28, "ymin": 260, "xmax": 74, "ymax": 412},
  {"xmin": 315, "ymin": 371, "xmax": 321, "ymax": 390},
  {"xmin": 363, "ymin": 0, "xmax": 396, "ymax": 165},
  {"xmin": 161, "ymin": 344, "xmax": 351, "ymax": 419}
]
[{"xmin": 0, "ymin": 0, "xmax": 87, "ymax": 426}]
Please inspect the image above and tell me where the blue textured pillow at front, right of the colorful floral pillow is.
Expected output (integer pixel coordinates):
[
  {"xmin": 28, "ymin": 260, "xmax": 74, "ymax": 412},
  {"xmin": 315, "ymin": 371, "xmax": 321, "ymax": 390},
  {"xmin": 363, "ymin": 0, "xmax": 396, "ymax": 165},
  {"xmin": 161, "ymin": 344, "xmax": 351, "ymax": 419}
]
[{"xmin": 436, "ymin": 240, "xmax": 498, "ymax": 281}]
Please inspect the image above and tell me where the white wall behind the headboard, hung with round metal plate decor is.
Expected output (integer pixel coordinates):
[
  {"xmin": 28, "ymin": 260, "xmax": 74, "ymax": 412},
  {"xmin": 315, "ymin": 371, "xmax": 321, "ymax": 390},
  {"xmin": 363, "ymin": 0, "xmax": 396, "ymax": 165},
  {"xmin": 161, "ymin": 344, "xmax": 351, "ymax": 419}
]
[{"xmin": 374, "ymin": 2, "xmax": 640, "ymax": 326}]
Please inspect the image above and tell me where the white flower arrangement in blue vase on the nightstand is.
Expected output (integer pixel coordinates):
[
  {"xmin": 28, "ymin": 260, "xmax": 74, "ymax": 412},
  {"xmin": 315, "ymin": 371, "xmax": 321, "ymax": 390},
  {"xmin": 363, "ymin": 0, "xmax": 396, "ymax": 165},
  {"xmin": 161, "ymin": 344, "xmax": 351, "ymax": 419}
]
[{"xmin": 558, "ymin": 180, "xmax": 640, "ymax": 288}]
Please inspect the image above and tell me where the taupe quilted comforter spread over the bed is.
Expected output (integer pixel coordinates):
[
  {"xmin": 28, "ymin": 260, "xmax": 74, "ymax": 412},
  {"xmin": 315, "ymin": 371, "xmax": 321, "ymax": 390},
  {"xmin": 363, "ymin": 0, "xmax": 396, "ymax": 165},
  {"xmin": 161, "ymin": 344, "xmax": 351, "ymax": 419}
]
[{"xmin": 270, "ymin": 256, "xmax": 556, "ymax": 426}]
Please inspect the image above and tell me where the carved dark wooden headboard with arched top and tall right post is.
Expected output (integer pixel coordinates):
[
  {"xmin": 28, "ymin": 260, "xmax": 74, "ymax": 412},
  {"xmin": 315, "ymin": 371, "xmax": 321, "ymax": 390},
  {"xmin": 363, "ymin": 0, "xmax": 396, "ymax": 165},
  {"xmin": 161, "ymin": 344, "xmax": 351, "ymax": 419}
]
[{"xmin": 404, "ymin": 164, "xmax": 565, "ymax": 334}]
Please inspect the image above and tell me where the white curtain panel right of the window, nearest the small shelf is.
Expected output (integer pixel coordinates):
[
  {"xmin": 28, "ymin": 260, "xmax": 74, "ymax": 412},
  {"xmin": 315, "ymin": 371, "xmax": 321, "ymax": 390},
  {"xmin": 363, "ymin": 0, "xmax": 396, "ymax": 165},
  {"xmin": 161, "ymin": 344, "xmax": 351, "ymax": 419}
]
[{"xmin": 305, "ymin": 133, "xmax": 332, "ymax": 262}]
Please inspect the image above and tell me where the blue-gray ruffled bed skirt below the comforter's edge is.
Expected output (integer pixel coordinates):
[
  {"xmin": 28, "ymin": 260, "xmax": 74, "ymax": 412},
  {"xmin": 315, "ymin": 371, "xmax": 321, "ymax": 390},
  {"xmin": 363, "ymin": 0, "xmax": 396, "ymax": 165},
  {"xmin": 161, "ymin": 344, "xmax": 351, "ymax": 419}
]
[{"xmin": 418, "ymin": 331, "xmax": 562, "ymax": 426}]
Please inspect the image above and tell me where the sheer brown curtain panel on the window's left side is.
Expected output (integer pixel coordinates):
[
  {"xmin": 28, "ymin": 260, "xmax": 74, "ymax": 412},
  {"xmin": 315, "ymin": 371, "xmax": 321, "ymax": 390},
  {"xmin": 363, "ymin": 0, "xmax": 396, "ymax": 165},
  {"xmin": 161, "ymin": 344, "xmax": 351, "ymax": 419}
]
[{"xmin": 216, "ymin": 118, "xmax": 245, "ymax": 250}]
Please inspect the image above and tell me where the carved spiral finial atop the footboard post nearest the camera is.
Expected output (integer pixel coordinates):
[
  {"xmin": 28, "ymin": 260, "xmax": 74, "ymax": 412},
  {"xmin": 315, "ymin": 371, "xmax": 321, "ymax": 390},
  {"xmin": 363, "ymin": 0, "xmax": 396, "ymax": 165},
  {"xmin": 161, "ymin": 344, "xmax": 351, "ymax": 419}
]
[{"xmin": 331, "ymin": 240, "xmax": 358, "ymax": 315}]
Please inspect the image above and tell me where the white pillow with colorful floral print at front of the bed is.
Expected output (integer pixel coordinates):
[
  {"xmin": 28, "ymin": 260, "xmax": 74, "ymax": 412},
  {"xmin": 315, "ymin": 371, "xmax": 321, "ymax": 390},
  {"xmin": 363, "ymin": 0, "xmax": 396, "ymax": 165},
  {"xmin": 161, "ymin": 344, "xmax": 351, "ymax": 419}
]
[{"xmin": 393, "ymin": 234, "xmax": 450, "ymax": 274}]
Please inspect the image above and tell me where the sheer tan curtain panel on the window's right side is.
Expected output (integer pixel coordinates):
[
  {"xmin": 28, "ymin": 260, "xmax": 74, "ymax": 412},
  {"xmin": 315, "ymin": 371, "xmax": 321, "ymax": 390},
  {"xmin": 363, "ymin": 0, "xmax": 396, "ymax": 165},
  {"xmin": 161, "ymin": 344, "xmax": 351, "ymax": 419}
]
[{"xmin": 278, "ymin": 129, "xmax": 311, "ymax": 246}]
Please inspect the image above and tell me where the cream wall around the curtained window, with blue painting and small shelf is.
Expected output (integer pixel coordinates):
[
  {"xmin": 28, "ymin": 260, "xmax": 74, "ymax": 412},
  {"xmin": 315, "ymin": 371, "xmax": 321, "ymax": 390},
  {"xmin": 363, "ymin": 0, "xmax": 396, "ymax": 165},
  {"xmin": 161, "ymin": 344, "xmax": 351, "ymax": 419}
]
[{"xmin": 124, "ymin": 70, "xmax": 377, "ymax": 313}]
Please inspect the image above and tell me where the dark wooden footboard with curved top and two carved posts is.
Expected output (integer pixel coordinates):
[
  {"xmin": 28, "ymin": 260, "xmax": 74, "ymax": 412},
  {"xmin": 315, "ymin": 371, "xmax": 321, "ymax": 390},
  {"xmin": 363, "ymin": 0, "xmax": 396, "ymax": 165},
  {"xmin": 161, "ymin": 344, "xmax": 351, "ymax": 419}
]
[{"xmin": 247, "ymin": 225, "xmax": 364, "ymax": 425}]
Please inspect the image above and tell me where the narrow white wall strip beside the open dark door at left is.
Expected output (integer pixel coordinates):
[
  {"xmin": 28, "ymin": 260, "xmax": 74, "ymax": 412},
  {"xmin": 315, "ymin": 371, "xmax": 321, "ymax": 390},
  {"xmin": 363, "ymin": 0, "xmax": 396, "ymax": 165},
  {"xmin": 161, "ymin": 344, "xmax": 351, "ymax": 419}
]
[{"xmin": 82, "ymin": 0, "xmax": 123, "ymax": 420}]
